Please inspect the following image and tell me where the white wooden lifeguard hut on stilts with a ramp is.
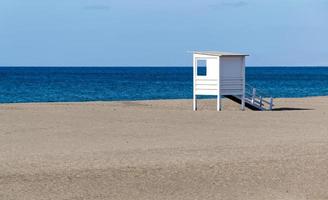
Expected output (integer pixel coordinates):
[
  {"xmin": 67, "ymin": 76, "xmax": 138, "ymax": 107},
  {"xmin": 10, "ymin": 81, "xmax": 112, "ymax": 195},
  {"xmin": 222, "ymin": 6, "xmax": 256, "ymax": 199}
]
[{"xmin": 193, "ymin": 51, "xmax": 273, "ymax": 111}]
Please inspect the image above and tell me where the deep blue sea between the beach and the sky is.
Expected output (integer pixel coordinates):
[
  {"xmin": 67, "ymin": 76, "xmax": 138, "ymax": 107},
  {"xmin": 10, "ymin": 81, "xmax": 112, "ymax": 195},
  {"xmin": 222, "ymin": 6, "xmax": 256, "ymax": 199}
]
[{"xmin": 0, "ymin": 67, "xmax": 328, "ymax": 103}]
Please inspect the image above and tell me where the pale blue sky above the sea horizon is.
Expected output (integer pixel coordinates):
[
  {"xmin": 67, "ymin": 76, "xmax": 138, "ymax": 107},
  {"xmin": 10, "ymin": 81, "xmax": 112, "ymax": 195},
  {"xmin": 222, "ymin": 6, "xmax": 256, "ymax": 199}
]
[{"xmin": 0, "ymin": 0, "xmax": 328, "ymax": 66}]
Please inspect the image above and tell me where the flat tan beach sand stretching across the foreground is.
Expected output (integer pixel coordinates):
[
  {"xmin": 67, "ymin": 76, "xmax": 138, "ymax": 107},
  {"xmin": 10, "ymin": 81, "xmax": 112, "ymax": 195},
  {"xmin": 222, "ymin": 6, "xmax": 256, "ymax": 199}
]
[{"xmin": 0, "ymin": 97, "xmax": 328, "ymax": 200}]
